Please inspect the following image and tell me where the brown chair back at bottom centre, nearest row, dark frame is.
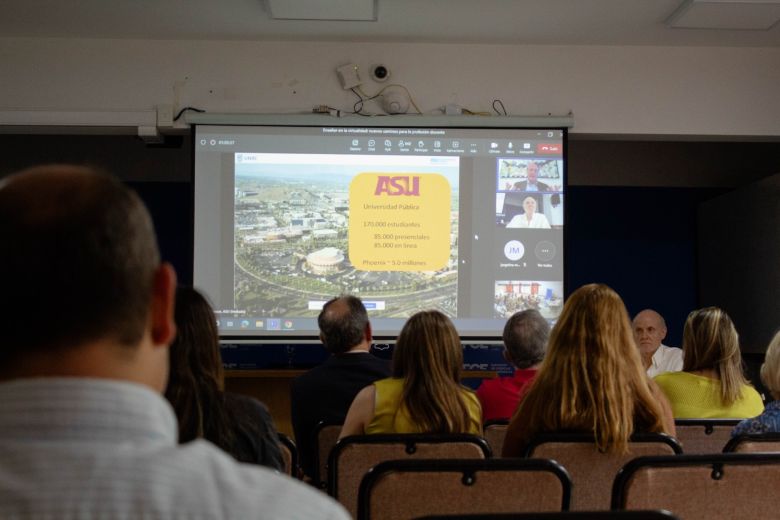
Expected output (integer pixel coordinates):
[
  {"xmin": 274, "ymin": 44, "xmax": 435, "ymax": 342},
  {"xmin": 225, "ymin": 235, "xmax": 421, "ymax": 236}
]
[{"xmin": 357, "ymin": 459, "xmax": 571, "ymax": 520}]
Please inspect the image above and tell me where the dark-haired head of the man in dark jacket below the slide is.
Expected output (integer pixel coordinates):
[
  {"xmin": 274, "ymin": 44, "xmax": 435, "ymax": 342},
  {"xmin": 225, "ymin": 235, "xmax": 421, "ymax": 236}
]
[{"xmin": 317, "ymin": 295, "xmax": 371, "ymax": 354}]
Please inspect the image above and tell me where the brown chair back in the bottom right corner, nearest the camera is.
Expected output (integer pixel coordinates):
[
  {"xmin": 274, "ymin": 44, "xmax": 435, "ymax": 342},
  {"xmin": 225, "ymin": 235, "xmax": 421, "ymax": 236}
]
[{"xmin": 612, "ymin": 453, "xmax": 780, "ymax": 520}]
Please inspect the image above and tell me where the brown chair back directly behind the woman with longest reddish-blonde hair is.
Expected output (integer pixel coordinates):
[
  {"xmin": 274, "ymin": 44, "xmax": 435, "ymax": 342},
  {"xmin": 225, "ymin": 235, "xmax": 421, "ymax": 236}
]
[{"xmin": 525, "ymin": 433, "xmax": 682, "ymax": 511}]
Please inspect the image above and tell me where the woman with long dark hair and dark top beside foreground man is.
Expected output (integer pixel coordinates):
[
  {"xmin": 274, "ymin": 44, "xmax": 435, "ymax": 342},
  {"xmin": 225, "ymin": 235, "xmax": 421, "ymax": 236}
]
[{"xmin": 165, "ymin": 287, "xmax": 284, "ymax": 470}]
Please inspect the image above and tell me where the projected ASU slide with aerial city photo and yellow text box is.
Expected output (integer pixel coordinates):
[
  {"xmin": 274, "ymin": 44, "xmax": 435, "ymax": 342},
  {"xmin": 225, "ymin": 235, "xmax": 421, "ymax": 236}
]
[{"xmin": 234, "ymin": 154, "xmax": 458, "ymax": 318}]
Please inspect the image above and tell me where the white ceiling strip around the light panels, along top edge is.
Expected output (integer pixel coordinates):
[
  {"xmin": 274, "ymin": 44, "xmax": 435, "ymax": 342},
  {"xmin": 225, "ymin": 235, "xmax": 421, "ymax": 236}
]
[{"xmin": 0, "ymin": 0, "xmax": 780, "ymax": 47}]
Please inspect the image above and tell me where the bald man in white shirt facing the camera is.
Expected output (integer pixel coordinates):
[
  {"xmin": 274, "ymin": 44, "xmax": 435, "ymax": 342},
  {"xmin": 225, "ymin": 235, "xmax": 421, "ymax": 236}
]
[{"xmin": 633, "ymin": 309, "xmax": 683, "ymax": 377}]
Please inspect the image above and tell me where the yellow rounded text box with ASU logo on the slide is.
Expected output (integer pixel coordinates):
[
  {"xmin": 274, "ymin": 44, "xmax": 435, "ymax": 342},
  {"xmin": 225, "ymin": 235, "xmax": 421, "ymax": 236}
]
[{"xmin": 349, "ymin": 172, "xmax": 451, "ymax": 271}]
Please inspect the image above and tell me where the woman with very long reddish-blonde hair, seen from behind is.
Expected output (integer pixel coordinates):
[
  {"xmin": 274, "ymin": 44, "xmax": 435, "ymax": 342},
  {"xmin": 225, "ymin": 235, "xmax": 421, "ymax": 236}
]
[{"xmin": 503, "ymin": 284, "xmax": 675, "ymax": 457}]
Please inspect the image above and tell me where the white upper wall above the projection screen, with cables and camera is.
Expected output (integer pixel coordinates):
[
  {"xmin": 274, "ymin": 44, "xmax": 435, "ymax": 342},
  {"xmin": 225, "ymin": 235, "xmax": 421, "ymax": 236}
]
[{"xmin": 0, "ymin": 38, "xmax": 780, "ymax": 138}]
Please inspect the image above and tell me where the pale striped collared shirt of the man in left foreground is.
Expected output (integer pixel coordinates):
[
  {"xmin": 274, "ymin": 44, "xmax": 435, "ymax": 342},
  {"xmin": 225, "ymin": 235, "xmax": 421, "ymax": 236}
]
[{"xmin": 0, "ymin": 377, "xmax": 349, "ymax": 520}]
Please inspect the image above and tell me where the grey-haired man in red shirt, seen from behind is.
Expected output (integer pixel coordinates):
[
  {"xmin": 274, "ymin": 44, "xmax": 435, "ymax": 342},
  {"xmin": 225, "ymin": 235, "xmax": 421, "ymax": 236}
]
[{"xmin": 477, "ymin": 310, "xmax": 550, "ymax": 421}]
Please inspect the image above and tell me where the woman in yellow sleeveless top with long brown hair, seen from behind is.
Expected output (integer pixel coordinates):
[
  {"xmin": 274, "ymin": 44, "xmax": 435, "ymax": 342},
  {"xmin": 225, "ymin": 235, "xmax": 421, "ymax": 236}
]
[{"xmin": 341, "ymin": 311, "xmax": 482, "ymax": 437}]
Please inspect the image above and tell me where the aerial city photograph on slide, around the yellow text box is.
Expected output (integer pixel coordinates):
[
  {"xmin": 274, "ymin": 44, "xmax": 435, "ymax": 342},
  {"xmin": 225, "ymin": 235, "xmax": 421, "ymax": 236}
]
[{"xmin": 234, "ymin": 158, "xmax": 458, "ymax": 318}]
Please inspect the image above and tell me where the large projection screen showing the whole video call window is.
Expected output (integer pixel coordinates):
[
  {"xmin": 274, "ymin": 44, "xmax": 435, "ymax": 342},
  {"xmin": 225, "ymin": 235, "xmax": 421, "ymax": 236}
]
[{"xmin": 193, "ymin": 124, "xmax": 566, "ymax": 341}]
